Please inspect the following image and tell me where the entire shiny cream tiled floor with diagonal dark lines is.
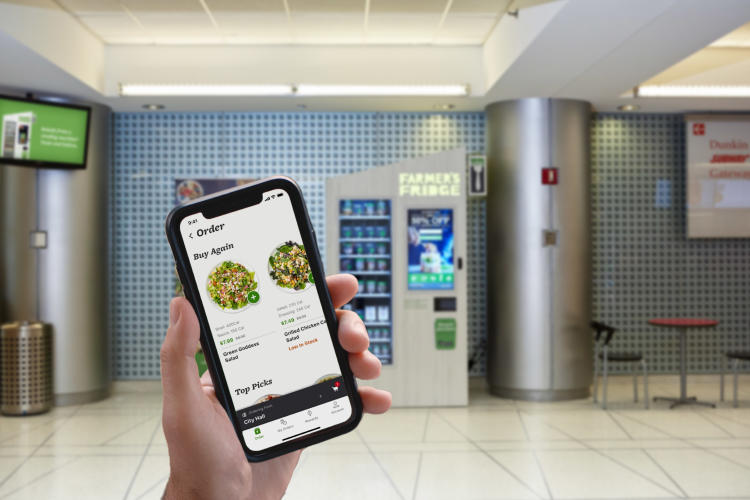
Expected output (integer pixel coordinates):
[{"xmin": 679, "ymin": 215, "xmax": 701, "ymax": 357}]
[{"xmin": 0, "ymin": 375, "xmax": 750, "ymax": 500}]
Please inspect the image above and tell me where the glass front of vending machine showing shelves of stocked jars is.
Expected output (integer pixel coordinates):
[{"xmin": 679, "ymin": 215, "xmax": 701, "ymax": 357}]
[{"xmin": 339, "ymin": 199, "xmax": 393, "ymax": 365}]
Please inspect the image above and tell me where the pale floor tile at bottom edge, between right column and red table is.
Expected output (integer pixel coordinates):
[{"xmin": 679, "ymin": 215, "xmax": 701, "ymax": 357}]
[{"xmin": 537, "ymin": 451, "xmax": 674, "ymax": 499}]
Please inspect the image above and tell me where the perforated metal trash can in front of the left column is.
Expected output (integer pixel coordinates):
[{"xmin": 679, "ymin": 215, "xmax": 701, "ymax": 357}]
[{"xmin": 0, "ymin": 321, "xmax": 53, "ymax": 415}]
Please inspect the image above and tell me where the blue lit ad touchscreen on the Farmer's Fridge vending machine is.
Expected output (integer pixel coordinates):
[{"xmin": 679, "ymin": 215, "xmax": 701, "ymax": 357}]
[{"xmin": 408, "ymin": 208, "xmax": 453, "ymax": 290}]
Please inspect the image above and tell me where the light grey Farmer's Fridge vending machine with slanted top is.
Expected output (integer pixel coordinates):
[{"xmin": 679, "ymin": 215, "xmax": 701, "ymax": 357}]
[{"xmin": 326, "ymin": 149, "xmax": 468, "ymax": 406}]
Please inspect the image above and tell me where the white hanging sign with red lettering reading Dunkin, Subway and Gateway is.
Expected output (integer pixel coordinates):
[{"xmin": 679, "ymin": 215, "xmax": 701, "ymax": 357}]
[{"xmin": 686, "ymin": 115, "xmax": 750, "ymax": 238}]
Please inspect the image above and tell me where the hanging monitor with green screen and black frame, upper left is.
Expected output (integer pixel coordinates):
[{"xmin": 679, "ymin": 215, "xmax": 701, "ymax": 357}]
[{"xmin": 0, "ymin": 96, "xmax": 91, "ymax": 168}]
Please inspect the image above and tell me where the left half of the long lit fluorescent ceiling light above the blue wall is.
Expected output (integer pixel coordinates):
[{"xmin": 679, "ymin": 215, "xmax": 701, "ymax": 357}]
[{"xmin": 120, "ymin": 83, "xmax": 294, "ymax": 97}]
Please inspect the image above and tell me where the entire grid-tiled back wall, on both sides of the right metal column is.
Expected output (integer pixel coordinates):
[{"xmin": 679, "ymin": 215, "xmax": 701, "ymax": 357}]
[{"xmin": 112, "ymin": 112, "xmax": 750, "ymax": 379}]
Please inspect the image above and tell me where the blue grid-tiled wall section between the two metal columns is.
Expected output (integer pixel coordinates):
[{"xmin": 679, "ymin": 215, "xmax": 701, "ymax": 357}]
[{"xmin": 112, "ymin": 112, "xmax": 486, "ymax": 379}]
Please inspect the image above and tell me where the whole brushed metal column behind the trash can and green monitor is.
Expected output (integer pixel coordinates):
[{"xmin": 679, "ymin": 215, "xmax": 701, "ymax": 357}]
[{"xmin": 0, "ymin": 99, "xmax": 112, "ymax": 405}]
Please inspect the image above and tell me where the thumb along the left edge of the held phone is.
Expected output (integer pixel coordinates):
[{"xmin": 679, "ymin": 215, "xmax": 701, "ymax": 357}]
[{"xmin": 160, "ymin": 297, "xmax": 202, "ymax": 406}]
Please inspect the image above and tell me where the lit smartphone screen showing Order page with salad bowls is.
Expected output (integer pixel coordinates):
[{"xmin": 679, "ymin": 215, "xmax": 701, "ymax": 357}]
[{"xmin": 180, "ymin": 189, "xmax": 352, "ymax": 451}]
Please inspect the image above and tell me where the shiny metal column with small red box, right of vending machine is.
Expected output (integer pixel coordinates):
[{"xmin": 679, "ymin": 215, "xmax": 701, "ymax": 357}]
[{"xmin": 486, "ymin": 98, "xmax": 592, "ymax": 400}]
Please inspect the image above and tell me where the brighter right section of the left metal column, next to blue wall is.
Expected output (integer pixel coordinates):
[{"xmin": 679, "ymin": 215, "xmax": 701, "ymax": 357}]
[{"xmin": 39, "ymin": 100, "xmax": 111, "ymax": 405}]
